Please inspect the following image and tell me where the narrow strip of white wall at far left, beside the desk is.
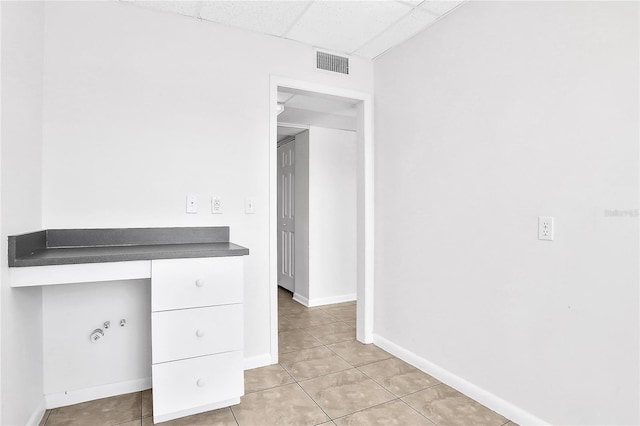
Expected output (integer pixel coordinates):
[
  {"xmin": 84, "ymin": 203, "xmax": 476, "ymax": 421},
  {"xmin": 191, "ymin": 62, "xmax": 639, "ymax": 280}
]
[{"xmin": 0, "ymin": 2, "xmax": 44, "ymax": 425}]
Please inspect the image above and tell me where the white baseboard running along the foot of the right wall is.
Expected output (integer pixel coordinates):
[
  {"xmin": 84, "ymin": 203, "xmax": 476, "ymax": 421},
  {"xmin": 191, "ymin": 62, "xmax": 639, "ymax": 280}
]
[{"xmin": 373, "ymin": 334, "xmax": 550, "ymax": 426}]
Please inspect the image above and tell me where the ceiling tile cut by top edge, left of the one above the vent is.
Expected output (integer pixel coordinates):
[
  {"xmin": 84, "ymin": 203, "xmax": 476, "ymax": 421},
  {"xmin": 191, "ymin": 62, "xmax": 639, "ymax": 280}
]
[{"xmin": 200, "ymin": 1, "xmax": 311, "ymax": 36}]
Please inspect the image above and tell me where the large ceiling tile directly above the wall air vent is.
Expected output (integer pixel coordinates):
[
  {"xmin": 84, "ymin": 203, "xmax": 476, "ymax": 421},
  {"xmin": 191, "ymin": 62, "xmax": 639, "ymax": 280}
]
[{"xmin": 285, "ymin": 1, "xmax": 411, "ymax": 53}]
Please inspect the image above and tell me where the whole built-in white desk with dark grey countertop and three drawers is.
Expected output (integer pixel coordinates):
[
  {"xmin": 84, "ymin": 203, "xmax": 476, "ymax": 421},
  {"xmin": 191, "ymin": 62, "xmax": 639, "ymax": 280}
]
[{"xmin": 8, "ymin": 227, "xmax": 249, "ymax": 423}]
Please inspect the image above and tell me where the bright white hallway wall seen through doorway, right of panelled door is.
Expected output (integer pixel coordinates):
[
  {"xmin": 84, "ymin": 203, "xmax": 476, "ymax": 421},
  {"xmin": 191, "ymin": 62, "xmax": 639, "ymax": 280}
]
[{"xmin": 309, "ymin": 126, "xmax": 356, "ymax": 305}]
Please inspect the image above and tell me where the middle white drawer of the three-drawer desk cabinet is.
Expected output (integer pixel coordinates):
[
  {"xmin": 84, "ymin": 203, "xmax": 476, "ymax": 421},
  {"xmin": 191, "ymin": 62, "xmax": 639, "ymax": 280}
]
[{"xmin": 151, "ymin": 304, "xmax": 244, "ymax": 364}]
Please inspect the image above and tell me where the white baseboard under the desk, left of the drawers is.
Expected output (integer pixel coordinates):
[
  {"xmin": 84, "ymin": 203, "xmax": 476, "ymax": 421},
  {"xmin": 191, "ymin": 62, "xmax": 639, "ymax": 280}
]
[{"xmin": 44, "ymin": 377, "xmax": 151, "ymax": 409}]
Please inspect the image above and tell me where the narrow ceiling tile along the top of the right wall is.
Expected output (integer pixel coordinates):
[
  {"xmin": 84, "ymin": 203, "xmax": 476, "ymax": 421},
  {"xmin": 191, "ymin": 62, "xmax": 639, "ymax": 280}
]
[{"xmin": 355, "ymin": 9, "xmax": 437, "ymax": 59}]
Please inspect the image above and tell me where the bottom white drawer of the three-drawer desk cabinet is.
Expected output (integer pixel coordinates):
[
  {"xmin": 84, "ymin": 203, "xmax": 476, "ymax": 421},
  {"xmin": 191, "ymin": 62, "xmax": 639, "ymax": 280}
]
[{"xmin": 152, "ymin": 351, "xmax": 244, "ymax": 418}]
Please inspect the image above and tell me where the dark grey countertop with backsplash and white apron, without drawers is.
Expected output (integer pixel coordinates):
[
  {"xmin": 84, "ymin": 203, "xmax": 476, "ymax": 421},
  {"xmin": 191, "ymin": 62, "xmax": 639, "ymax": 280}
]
[{"xmin": 9, "ymin": 226, "xmax": 249, "ymax": 287}]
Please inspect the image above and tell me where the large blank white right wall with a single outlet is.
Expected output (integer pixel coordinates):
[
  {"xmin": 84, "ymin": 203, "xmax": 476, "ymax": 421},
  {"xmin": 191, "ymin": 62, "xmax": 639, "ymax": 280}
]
[{"xmin": 375, "ymin": 2, "xmax": 640, "ymax": 425}]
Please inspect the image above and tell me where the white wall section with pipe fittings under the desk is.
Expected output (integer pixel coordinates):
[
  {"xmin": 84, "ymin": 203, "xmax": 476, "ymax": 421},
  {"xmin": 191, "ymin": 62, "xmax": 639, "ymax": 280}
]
[{"xmin": 42, "ymin": 280, "xmax": 151, "ymax": 408}]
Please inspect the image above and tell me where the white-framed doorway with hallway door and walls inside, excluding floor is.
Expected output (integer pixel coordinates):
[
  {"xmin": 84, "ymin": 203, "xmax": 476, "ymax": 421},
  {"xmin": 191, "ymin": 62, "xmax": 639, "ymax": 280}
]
[{"xmin": 269, "ymin": 77, "xmax": 373, "ymax": 363}]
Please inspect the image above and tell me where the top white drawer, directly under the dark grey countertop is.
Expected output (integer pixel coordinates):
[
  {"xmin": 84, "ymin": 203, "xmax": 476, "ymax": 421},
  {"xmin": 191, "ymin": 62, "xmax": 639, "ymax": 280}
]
[{"xmin": 151, "ymin": 256, "xmax": 243, "ymax": 311}]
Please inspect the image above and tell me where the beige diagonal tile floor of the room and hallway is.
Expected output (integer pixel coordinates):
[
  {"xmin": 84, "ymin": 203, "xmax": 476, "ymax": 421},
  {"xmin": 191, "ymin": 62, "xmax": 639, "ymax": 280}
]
[{"xmin": 40, "ymin": 289, "xmax": 517, "ymax": 426}]
